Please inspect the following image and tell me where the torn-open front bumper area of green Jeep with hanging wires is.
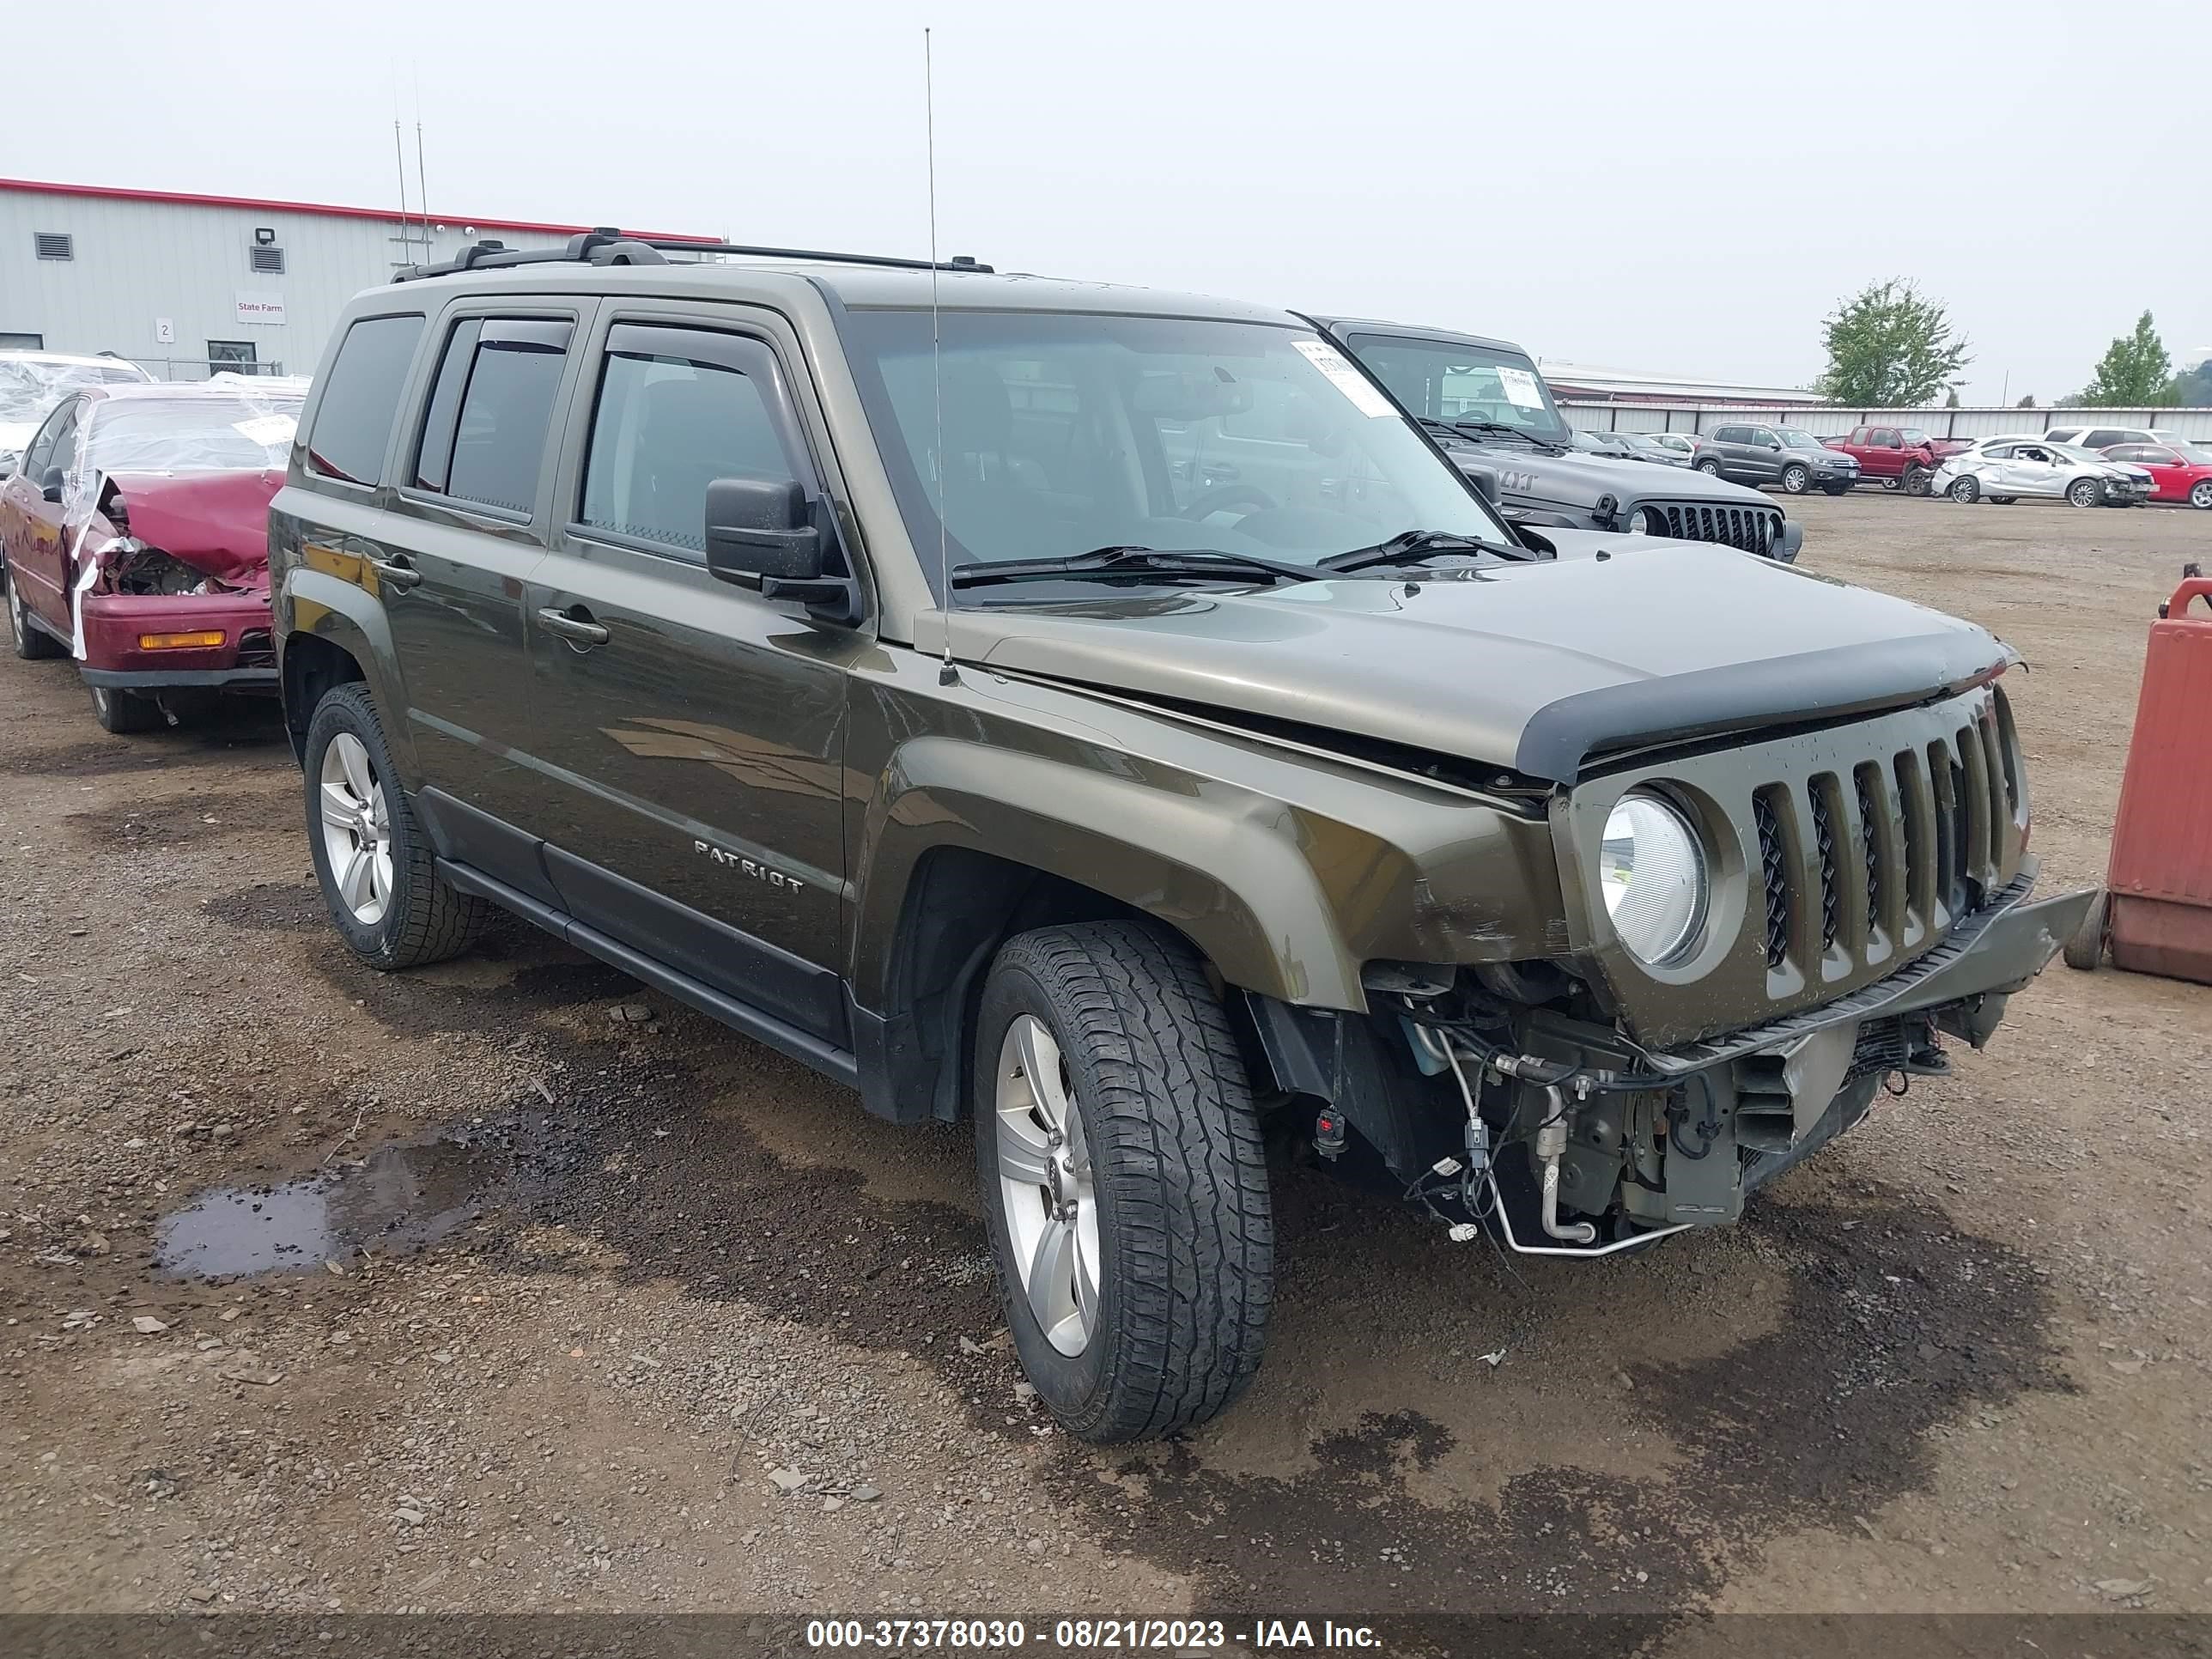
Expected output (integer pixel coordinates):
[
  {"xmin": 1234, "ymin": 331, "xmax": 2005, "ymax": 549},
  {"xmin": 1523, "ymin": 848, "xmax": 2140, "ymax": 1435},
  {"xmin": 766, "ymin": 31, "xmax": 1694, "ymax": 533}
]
[{"xmin": 1245, "ymin": 874, "xmax": 2093, "ymax": 1255}]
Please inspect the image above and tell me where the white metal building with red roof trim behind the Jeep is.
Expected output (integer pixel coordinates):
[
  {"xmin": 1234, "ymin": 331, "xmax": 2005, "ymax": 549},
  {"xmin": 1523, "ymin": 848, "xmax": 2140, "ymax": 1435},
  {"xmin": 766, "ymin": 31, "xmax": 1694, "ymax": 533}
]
[{"xmin": 0, "ymin": 179, "xmax": 708, "ymax": 380}]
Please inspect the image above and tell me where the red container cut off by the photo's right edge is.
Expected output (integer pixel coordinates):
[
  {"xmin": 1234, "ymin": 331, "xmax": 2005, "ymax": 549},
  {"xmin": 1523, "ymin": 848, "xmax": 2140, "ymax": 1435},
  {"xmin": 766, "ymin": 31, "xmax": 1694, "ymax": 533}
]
[{"xmin": 2093, "ymin": 575, "xmax": 2212, "ymax": 984}]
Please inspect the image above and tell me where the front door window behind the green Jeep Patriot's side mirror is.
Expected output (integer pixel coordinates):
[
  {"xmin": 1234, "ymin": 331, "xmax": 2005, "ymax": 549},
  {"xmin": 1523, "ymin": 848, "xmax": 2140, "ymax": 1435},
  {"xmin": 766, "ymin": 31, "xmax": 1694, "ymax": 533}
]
[{"xmin": 580, "ymin": 323, "xmax": 794, "ymax": 553}]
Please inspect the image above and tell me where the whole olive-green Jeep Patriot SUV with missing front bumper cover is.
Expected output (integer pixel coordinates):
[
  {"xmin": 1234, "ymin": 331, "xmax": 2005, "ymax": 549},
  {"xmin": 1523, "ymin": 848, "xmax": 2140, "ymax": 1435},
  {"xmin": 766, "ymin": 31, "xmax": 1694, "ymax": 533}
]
[{"xmin": 270, "ymin": 232, "xmax": 2086, "ymax": 1440}]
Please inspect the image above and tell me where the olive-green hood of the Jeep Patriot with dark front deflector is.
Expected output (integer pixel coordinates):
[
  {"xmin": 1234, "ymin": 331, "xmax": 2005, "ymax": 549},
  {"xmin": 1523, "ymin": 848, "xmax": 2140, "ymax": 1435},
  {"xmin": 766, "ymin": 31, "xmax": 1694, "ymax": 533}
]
[{"xmin": 951, "ymin": 539, "xmax": 2011, "ymax": 783}]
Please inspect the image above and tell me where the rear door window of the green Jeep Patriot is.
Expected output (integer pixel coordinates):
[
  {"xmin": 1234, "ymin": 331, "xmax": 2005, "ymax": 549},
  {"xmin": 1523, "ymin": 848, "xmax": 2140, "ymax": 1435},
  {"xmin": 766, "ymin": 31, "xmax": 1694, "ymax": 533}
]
[{"xmin": 414, "ymin": 316, "xmax": 575, "ymax": 514}]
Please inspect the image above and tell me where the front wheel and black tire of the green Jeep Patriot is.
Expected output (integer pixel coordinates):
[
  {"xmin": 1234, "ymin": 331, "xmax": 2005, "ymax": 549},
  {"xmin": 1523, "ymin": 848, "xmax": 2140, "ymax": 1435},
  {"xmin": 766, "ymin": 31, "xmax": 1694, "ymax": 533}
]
[{"xmin": 973, "ymin": 922, "xmax": 1274, "ymax": 1443}]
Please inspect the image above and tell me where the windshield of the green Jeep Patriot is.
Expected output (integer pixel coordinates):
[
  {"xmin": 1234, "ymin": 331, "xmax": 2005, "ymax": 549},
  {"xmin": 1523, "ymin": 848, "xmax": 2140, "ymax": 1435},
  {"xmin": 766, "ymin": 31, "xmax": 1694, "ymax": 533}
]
[{"xmin": 845, "ymin": 310, "xmax": 1513, "ymax": 598}]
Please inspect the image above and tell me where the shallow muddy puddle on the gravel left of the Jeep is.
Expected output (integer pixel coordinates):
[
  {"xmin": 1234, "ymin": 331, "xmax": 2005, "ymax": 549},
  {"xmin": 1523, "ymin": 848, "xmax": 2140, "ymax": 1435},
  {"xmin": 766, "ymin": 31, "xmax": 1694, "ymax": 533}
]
[{"xmin": 155, "ymin": 1117, "xmax": 564, "ymax": 1279}]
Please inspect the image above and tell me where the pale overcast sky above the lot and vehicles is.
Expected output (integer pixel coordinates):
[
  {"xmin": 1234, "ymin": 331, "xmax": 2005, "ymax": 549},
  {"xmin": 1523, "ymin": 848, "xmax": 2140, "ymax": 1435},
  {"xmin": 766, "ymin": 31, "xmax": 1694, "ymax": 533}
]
[{"xmin": 21, "ymin": 0, "xmax": 2212, "ymax": 403}]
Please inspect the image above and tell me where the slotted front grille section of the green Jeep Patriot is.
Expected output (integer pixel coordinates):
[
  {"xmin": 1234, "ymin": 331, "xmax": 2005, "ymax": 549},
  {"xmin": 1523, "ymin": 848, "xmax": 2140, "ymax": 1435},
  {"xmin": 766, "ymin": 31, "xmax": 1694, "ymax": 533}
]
[{"xmin": 1752, "ymin": 699, "xmax": 2017, "ymax": 978}]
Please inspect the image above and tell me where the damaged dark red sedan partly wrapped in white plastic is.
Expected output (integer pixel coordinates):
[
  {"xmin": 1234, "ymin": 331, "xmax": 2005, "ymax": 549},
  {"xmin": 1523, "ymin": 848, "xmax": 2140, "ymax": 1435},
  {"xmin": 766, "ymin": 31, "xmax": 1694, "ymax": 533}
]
[{"xmin": 0, "ymin": 389, "xmax": 305, "ymax": 732}]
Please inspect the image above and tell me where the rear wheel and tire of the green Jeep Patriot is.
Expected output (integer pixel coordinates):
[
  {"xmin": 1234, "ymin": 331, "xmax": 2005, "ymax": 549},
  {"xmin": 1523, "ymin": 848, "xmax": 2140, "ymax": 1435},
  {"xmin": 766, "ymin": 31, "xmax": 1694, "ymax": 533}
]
[{"xmin": 305, "ymin": 681, "xmax": 491, "ymax": 971}]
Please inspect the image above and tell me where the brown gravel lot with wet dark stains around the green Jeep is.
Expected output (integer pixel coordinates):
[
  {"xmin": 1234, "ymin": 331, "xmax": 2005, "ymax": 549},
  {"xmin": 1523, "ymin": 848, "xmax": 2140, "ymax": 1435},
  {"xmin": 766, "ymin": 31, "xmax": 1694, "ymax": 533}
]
[{"xmin": 0, "ymin": 493, "xmax": 2212, "ymax": 1614}]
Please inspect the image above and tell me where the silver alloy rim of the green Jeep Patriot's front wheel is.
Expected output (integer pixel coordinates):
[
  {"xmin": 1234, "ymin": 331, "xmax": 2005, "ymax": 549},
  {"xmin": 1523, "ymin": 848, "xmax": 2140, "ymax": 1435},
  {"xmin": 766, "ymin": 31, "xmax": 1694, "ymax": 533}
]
[{"xmin": 995, "ymin": 1013, "xmax": 1099, "ymax": 1358}]
